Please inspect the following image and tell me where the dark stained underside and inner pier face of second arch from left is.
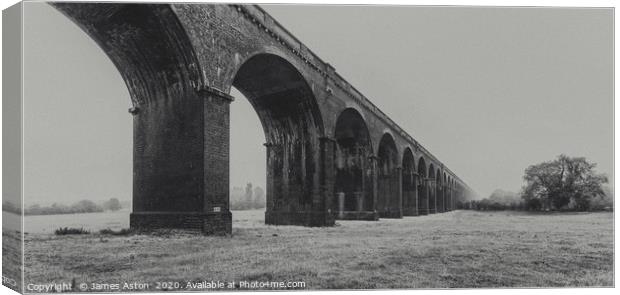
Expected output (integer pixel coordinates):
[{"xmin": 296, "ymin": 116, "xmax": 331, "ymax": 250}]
[{"xmin": 232, "ymin": 54, "xmax": 323, "ymax": 224}]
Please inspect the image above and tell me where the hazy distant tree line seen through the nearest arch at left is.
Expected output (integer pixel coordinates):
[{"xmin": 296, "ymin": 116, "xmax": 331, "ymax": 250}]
[{"xmin": 2, "ymin": 198, "xmax": 122, "ymax": 215}]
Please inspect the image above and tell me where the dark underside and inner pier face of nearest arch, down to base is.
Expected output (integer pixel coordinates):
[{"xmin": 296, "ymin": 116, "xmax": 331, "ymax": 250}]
[{"xmin": 51, "ymin": 3, "xmax": 225, "ymax": 230}]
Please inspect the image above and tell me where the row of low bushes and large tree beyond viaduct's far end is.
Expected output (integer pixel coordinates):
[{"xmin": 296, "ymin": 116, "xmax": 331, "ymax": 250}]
[{"xmin": 458, "ymin": 155, "xmax": 613, "ymax": 211}]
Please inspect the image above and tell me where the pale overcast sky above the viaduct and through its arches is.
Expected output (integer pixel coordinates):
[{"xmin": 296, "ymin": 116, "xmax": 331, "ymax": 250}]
[{"xmin": 25, "ymin": 3, "xmax": 613, "ymax": 204}]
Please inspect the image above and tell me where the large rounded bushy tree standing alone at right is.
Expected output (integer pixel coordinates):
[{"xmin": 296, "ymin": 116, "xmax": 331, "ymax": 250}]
[{"xmin": 522, "ymin": 155, "xmax": 608, "ymax": 211}]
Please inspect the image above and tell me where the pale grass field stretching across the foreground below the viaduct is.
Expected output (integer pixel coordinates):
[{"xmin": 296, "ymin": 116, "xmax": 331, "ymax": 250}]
[{"xmin": 19, "ymin": 211, "xmax": 614, "ymax": 291}]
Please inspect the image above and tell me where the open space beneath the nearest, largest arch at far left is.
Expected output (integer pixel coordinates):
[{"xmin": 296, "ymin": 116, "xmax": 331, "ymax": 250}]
[{"xmin": 26, "ymin": 2, "xmax": 132, "ymax": 232}]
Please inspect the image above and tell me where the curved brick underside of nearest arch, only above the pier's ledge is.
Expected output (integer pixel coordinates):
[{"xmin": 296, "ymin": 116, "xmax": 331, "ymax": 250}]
[{"xmin": 51, "ymin": 3, "xmax": 204, "ymax": 107}]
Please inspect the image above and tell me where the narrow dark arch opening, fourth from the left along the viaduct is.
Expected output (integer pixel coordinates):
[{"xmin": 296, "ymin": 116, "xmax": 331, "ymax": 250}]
[{"xmin": 377, "ymin": 133, "xmax": 402, "ymax": 218}]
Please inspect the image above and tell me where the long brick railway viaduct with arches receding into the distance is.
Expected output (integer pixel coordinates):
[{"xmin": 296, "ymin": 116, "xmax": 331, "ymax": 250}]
[{"xmin": 52, "ymin": 3, "xmax": 473, "ymax": 234}]
